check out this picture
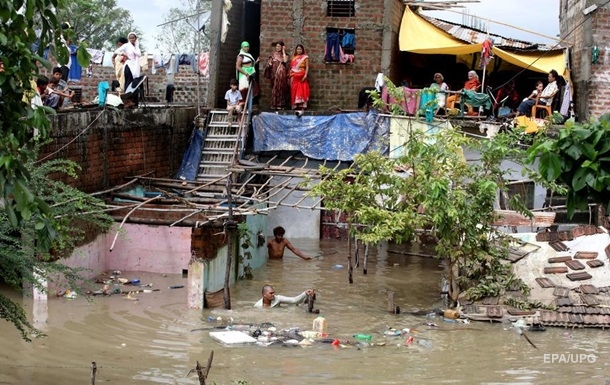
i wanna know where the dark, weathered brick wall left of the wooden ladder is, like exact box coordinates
[40,107,197,192]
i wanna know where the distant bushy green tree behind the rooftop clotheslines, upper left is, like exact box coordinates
[57,0,140,50]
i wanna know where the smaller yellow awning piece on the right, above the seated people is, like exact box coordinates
[492,47,566,75]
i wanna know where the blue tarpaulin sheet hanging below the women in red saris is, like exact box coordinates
[252,112,389,161]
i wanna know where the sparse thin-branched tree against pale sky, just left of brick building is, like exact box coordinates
[155,0,212,52]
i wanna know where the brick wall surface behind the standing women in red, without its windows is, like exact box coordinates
[246,0,402,110]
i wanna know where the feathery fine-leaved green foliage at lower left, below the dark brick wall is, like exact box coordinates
[0,146,113,341]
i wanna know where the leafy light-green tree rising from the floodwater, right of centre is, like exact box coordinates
[310,83,550,301]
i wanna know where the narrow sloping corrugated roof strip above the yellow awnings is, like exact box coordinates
[419,13,558,51]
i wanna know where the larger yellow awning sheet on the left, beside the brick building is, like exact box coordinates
[398,7,482,55]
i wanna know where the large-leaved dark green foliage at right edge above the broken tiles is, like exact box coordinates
[527,115,610,218]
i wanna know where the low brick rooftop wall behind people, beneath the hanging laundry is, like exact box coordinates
[41,59,207,105]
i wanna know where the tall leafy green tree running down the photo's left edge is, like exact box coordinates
[0,0,108,339]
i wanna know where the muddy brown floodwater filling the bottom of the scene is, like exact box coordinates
[0,240,610,385]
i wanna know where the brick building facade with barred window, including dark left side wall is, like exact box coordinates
[208,0,404,111]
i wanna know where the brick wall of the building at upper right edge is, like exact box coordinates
[559,0,610,121]
